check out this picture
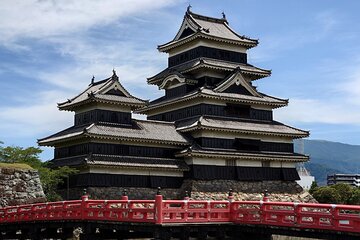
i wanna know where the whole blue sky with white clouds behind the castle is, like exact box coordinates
[0,0,360,160]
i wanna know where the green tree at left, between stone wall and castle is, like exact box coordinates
[0,142,77,201]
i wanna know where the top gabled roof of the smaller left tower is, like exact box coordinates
[58,71,146,111]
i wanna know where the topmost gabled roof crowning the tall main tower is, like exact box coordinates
[158,8,258,52]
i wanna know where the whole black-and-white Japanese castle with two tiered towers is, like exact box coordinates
[38,8,309,198]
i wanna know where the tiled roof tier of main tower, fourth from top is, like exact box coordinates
[177,116,309,138]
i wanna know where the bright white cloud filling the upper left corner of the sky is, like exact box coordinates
[0,0,179,46]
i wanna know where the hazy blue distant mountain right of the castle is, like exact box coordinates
[295,140,360,185]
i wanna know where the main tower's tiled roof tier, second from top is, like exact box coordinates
[148,57,271,85]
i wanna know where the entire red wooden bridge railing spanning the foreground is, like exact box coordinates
[0,194,360,233]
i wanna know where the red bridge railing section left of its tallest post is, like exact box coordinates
[0,196,155,224]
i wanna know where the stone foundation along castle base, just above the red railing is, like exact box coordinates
[60,180,316,202]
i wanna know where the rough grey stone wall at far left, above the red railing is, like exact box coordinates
[0,167,46,207]
